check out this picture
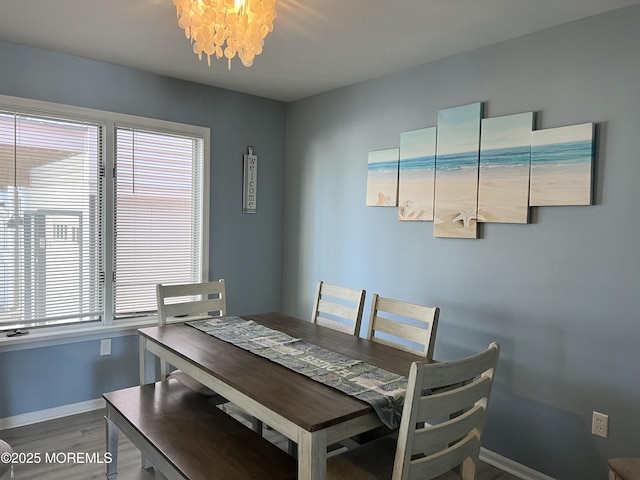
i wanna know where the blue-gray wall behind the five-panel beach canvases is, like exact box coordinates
[283,7,640,480]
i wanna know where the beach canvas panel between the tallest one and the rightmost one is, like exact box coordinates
[478,112,534,223]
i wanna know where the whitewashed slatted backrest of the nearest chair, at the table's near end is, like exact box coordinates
[393,342,500,480]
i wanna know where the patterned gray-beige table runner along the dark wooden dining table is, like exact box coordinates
[186,316,407,428]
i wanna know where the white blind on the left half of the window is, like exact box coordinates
[0,111,103,328]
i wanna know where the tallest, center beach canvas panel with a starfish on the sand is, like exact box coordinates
[433,103,482,238]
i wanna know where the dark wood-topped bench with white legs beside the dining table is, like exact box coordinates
[103,379,297,480]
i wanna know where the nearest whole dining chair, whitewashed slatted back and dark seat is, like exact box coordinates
[327,342,500,480]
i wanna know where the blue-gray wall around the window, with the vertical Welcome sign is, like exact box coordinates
[0,42,286,418]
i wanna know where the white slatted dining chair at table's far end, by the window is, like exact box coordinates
[156,279,227,405]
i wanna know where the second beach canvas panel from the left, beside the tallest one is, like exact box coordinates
[398,127,436,221]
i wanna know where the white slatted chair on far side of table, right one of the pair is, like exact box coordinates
[367,294,440,360]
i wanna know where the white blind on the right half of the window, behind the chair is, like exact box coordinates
[113,128,203,318]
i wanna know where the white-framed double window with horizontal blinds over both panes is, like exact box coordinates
[0,97,208,330]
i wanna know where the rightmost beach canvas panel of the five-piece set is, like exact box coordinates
[529,123,594,206]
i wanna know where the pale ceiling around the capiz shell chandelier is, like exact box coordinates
[0,0,640,101]
